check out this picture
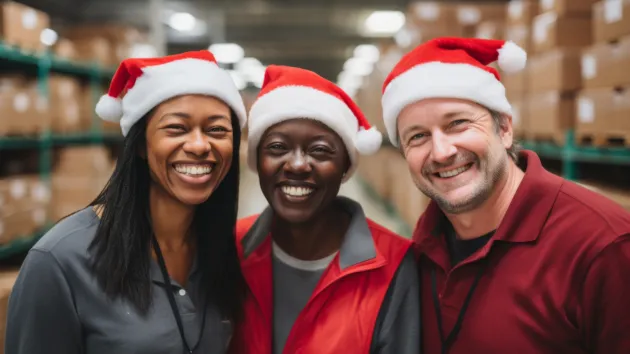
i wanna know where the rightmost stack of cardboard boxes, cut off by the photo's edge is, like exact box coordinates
[575,0,630,146]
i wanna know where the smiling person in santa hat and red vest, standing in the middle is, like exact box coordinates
[231,66,420,354]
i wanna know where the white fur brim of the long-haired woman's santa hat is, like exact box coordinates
[120,58,247,135]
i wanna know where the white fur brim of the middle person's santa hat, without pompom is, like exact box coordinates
[247,86,359,181]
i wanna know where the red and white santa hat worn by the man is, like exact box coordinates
[382,38,527,145]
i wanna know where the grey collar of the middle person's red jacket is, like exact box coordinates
[241,197,376,270]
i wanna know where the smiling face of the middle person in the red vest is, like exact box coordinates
[258,119,349,223]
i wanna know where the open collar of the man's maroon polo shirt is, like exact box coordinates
[413,150,564,252]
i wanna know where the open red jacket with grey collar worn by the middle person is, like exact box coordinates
[230,198,420,354]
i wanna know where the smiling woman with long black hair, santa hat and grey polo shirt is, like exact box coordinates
[5,51,251,354]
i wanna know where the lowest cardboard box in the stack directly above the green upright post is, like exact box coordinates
[526,91,575,139]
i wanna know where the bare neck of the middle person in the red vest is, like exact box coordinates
[271,204,350,261]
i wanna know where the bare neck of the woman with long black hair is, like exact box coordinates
[149,185,195,252]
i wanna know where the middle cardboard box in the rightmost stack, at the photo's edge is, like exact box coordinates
[581,36,630,88]
